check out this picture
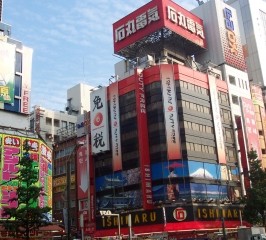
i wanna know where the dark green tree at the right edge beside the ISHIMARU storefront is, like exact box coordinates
[243,149,266,226]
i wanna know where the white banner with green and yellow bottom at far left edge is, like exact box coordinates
[0,41,16,103]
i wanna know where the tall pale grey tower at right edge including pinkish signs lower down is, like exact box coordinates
[226,0,266,169]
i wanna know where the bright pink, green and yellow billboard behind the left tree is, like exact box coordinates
[0,134,52,219]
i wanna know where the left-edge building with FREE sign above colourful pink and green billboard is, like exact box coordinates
[0,0,52,239]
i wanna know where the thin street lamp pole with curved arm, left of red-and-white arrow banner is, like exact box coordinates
[66,142,84,240]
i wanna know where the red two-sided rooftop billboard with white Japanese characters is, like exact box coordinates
[113,0,206,53]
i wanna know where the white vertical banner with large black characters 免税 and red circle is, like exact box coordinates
[90,87,110,154]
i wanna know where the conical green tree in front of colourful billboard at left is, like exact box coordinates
[3,140,51,240]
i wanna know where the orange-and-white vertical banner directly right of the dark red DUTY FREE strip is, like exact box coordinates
[160,64,182,160]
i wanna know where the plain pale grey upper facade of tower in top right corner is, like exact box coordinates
[226,0,266,86]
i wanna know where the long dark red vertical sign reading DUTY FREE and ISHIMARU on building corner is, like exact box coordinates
[135,69,153,209]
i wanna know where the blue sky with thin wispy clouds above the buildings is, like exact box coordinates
[2,0,198,110]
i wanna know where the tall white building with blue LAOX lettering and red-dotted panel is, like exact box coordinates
[192,0,266,172]
